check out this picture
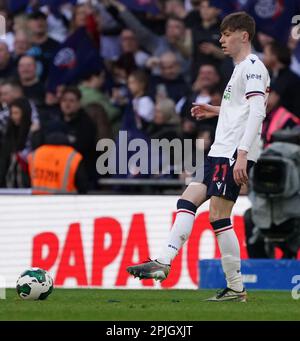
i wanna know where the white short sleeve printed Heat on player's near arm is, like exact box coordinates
[243,59,267,99]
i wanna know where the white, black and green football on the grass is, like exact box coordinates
[16,268,53,300]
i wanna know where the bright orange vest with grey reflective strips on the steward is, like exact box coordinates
[28,144,82,194]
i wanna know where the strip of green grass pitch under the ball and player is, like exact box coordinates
[0,289,300,321]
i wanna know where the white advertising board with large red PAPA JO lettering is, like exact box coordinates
[0,195,250,289]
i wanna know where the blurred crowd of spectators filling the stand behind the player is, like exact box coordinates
[0,0,300,193]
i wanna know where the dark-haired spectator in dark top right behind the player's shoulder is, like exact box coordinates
[263,41,300,117]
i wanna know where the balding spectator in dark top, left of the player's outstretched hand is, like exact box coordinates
[149,51,188,103]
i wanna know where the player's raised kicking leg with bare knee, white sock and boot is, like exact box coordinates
[127,182,207,281]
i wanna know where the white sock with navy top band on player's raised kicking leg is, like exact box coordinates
[157,199,197,264]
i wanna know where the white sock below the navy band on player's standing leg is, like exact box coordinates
[215,222,244,291]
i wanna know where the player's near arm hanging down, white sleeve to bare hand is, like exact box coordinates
[233,61,268,185]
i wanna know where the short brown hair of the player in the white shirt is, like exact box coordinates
[220,12,256,41]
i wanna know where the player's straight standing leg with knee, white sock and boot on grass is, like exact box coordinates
[209,196,246,302]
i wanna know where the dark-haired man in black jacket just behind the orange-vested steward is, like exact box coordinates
[60,87,96,188]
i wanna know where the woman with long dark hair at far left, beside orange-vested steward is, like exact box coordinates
[0,98,38,188]
